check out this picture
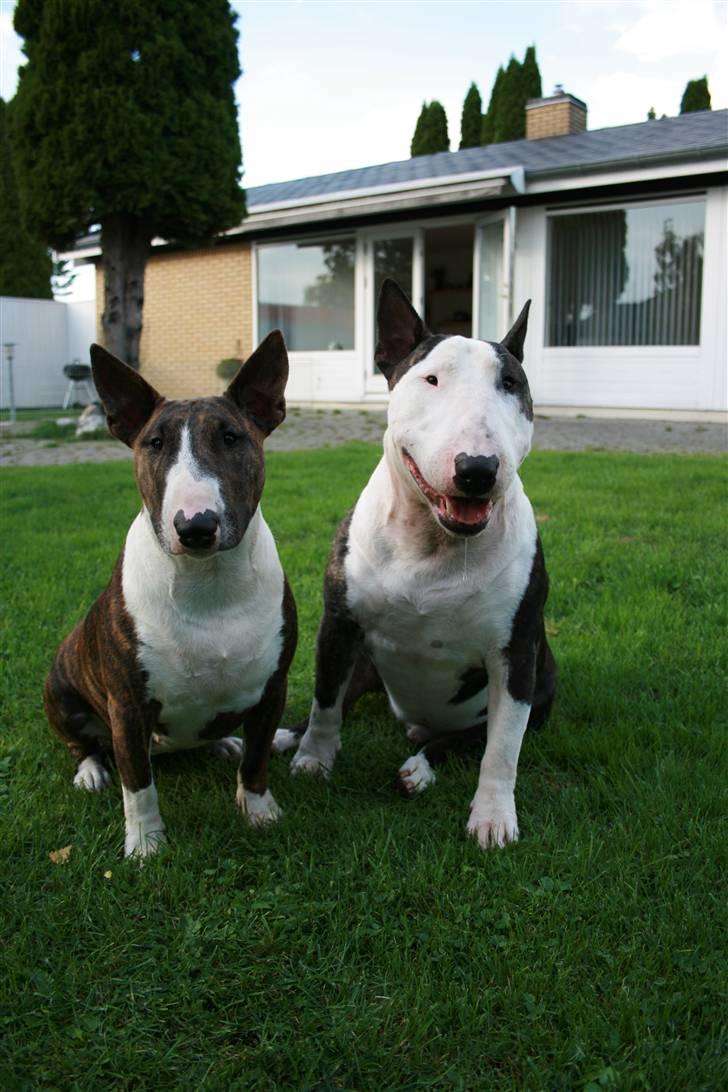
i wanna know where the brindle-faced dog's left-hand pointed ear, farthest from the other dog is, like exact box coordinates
[91,345,164,448]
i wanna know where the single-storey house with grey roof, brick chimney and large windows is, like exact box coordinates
[82,90,728,417]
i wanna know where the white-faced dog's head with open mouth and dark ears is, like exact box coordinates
[377,281,534,535]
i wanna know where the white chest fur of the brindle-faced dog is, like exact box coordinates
[122,509,284,750]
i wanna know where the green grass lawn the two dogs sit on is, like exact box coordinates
[0,444,728,1092]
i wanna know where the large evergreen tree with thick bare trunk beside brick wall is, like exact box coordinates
[13,0,244,366]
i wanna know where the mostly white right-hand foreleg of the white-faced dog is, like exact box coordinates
[467,661,530,850]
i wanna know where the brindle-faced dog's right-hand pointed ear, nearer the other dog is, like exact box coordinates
[225,330,288,436]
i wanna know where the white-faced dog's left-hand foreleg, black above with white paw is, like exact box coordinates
[290,613,363,776]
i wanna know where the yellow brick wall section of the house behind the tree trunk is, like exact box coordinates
[96,242,253,399]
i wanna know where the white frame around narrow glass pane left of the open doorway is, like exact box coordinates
[357,224,425,395]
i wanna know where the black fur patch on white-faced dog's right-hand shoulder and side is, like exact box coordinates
[503,535,557,711]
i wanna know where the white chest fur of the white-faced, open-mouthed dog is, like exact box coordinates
[346,456,536,731]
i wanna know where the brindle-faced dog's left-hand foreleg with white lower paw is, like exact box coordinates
[108,695,166,857]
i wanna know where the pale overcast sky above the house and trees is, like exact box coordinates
[0,0,728,192]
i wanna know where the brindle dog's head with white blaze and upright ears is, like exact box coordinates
[92,331,288,557]
